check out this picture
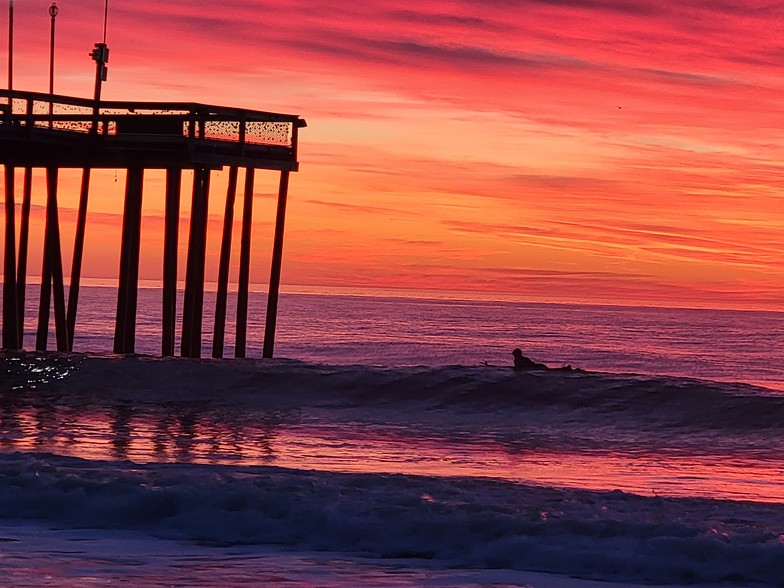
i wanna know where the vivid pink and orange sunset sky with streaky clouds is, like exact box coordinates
[0,0,784,311]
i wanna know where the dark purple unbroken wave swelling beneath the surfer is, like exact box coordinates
[0,353,784,431]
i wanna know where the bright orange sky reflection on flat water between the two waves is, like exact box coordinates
[0,404,784,503]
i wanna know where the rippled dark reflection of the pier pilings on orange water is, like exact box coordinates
[0,385,299,463]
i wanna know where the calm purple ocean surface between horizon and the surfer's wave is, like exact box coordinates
[15,286,784,391]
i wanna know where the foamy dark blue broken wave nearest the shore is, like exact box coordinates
[0,453,784,585]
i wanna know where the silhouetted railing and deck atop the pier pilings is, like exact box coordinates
[0,90,305,171]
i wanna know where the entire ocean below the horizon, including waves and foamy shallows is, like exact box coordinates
[0,286,784,588]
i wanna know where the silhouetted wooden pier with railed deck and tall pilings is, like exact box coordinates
[0,90,305,357]
